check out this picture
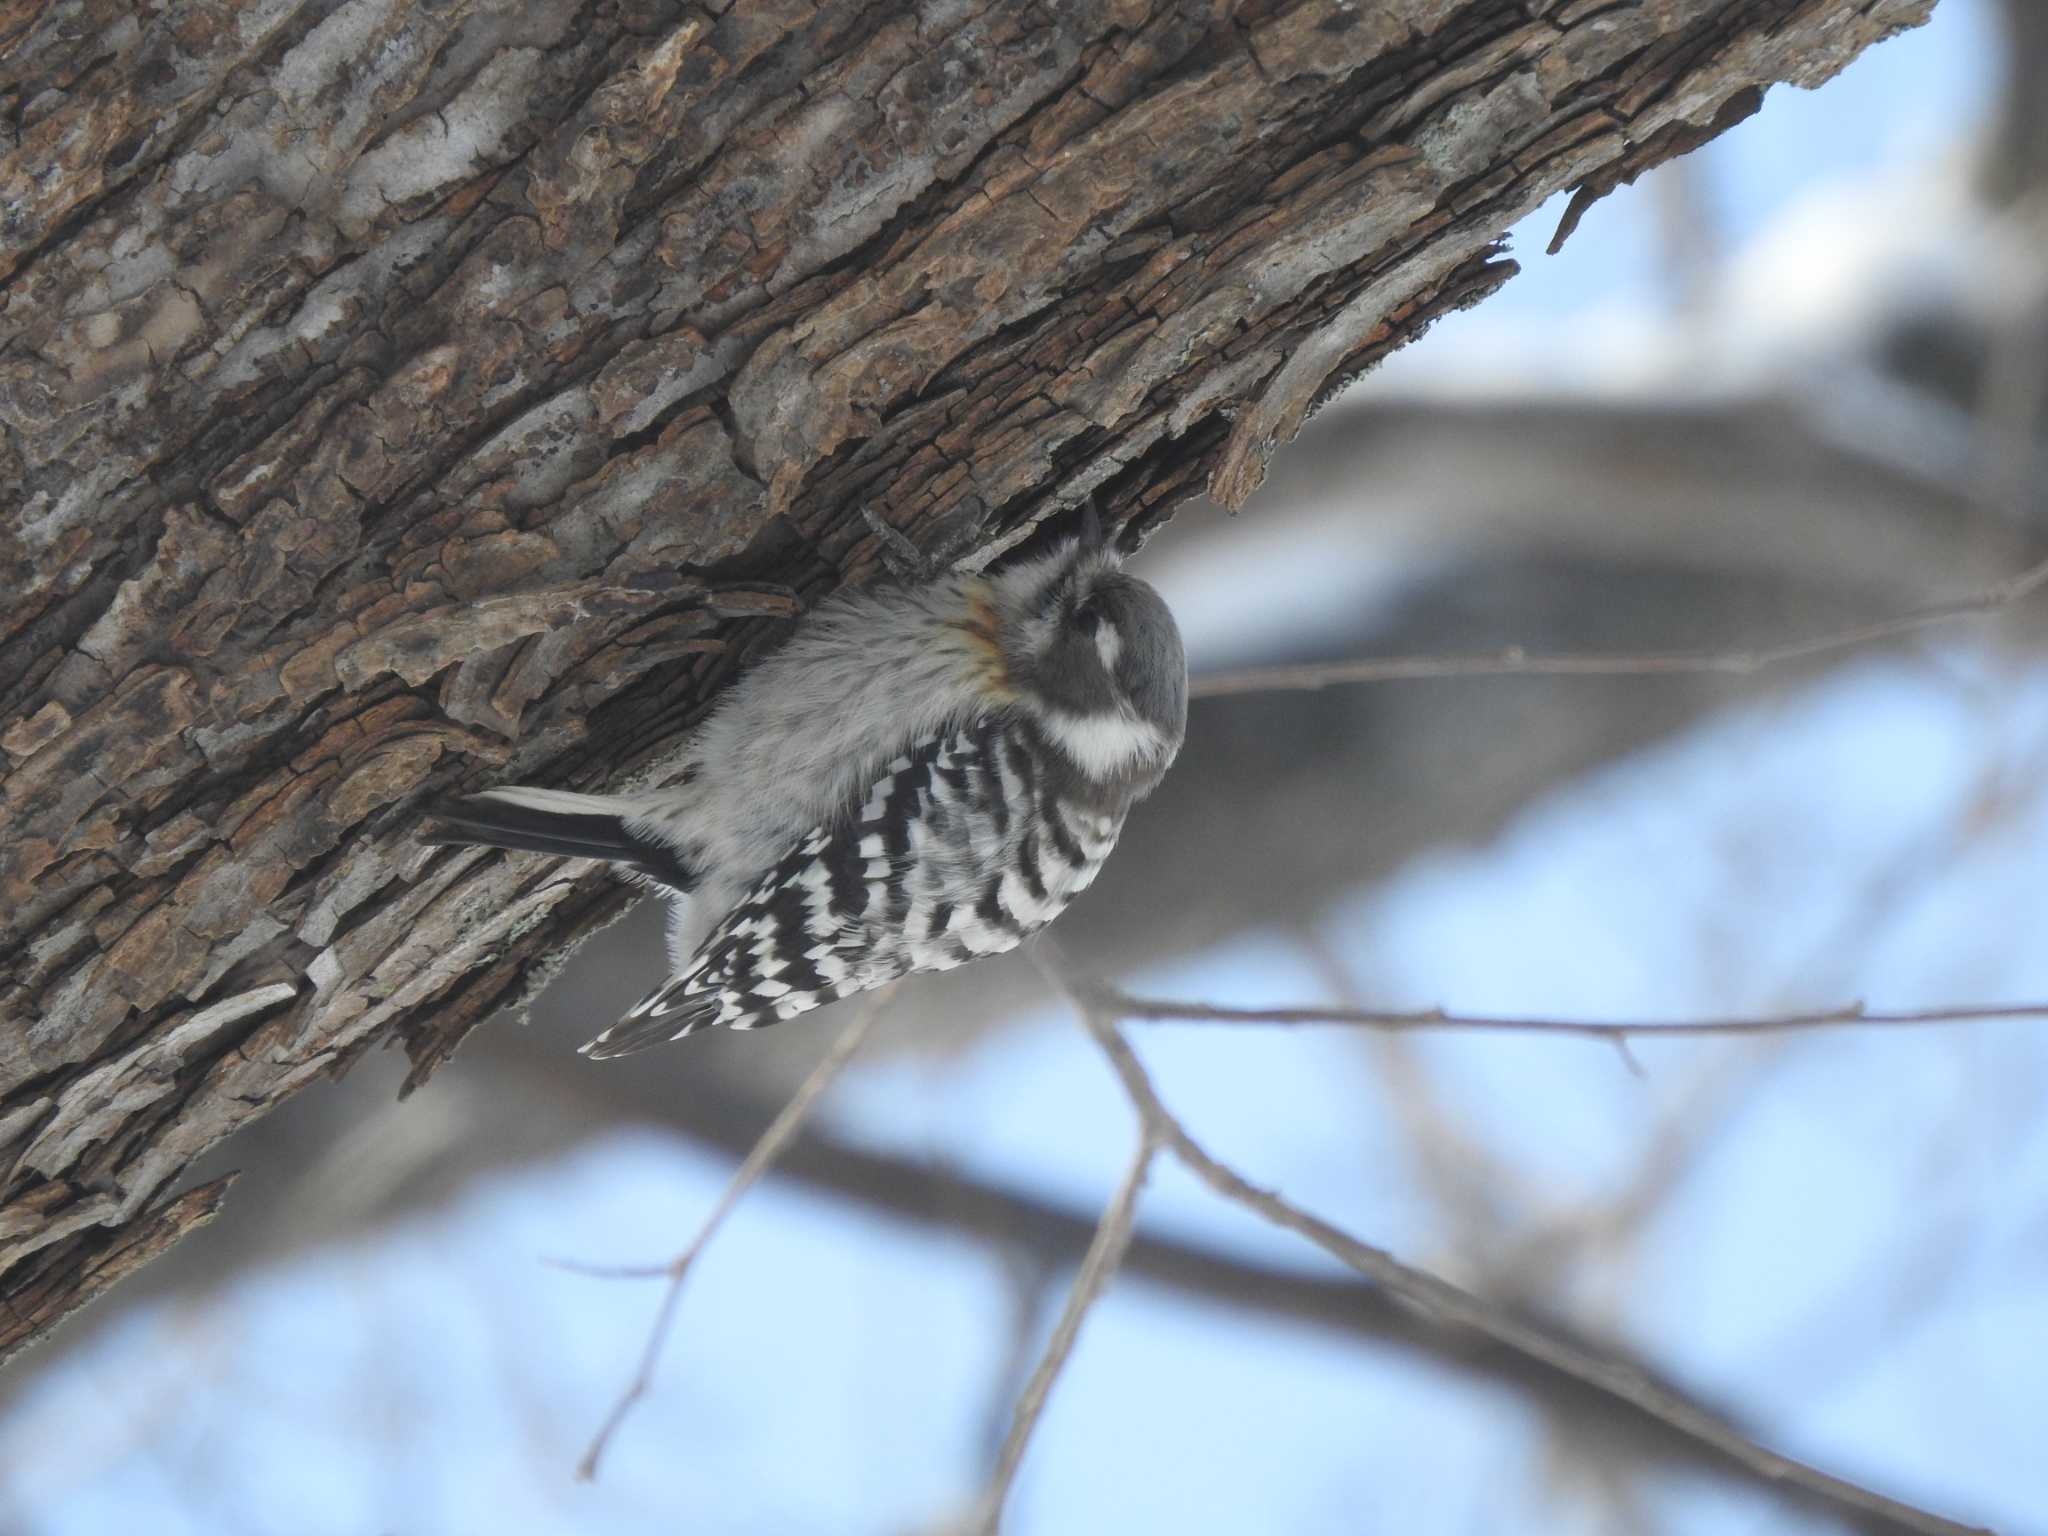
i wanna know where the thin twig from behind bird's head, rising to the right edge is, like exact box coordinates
[1188,561,2048,698]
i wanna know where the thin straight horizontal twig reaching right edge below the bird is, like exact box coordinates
[1097,981,2048,1047]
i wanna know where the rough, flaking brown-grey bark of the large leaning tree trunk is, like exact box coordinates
[0,0,1931,1350]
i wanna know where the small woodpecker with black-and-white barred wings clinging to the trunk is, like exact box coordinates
[422,516,1188,1059]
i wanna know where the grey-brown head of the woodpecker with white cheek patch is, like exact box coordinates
[991,518,1188,791]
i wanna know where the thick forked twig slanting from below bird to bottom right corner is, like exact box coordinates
[1036,954,1985,1536]
